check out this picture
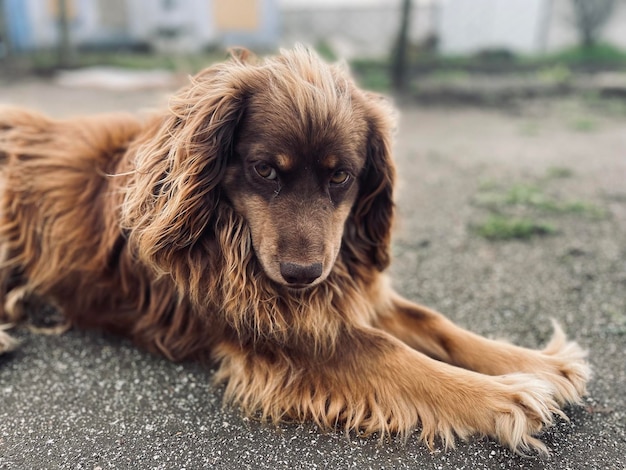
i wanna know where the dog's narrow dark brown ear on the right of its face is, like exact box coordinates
[344,94,395,271]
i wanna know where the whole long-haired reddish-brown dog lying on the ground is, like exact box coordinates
[0,47,589,452]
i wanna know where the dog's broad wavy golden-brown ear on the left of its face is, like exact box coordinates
[122,59,249,274]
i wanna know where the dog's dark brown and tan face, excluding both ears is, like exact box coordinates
[224,86,367,288]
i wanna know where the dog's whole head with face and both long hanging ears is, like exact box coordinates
[124,47,394,294]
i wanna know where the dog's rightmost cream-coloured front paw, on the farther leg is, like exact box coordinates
[535,322,591,405]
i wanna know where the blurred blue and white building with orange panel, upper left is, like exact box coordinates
[2,0,279,53]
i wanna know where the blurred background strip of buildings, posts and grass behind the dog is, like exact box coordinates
[0,0,626,101]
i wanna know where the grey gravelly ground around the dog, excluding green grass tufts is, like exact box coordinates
[0,81,626,469]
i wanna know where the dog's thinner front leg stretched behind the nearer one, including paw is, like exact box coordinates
[376,294,590,404]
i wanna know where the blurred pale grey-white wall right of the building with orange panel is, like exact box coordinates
[280,0,626,57]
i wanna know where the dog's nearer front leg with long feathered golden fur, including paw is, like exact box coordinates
[216,328,560,452]
